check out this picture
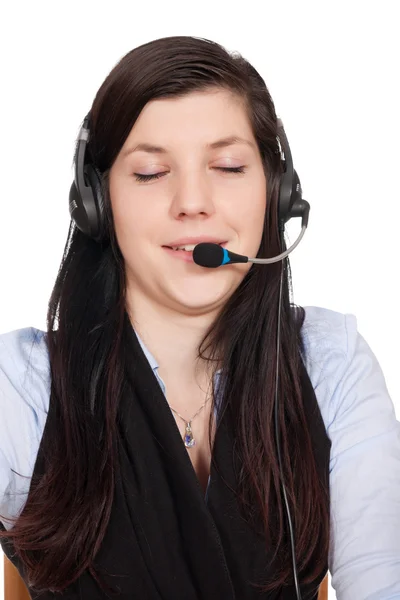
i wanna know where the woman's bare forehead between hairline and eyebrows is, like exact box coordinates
[121,90,255,157]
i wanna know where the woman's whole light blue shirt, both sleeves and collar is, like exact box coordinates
[0,306,400,600]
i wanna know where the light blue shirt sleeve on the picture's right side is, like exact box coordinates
[327,315,400,600]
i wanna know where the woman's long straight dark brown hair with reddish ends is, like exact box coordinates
[1,36,329,591]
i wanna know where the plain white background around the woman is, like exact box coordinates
[0,0,400,599]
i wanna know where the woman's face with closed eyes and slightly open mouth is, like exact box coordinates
[110,90,267,315]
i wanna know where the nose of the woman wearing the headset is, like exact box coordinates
[170,171,215,219]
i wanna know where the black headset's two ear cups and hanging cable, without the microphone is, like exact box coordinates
[69,112,310,600]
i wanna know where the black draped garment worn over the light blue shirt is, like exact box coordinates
[0,313,331,600]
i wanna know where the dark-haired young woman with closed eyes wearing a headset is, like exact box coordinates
[0,36,400,600]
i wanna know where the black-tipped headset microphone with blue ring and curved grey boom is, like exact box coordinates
[193,225,307,269]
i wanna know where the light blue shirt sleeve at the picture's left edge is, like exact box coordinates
[0,327,50,526]
